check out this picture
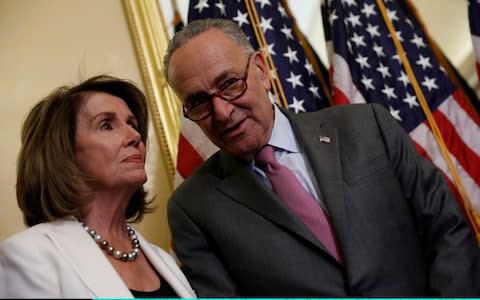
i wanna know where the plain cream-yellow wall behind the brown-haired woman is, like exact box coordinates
[0,0,171,247]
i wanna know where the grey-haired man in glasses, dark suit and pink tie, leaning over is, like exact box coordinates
[164,19,480,297]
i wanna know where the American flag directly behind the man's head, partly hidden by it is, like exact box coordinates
[175,0,331,185]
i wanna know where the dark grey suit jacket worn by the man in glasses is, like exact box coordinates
[168,104,480,297]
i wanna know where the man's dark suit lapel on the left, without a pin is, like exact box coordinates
[218,152,326,251]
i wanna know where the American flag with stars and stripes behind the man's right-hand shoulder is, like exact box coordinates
[322,0,480,238]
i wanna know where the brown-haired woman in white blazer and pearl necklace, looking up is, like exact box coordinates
[0,75,195,298]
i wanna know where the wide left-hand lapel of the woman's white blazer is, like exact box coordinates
[47,217,133,298]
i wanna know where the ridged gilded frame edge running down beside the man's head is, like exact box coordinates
[123,0,181,187]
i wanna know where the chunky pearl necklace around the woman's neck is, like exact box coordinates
[80,222,140,261]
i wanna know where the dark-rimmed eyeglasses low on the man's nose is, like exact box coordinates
[183,53,253,121]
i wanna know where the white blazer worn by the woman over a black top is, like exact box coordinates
[0,217,196,298]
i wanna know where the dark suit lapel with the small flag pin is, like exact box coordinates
[287,113,345,249]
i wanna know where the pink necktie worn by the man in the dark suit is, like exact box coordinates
[255,145,341,262]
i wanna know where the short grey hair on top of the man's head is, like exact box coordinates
[163,19,255,83]
